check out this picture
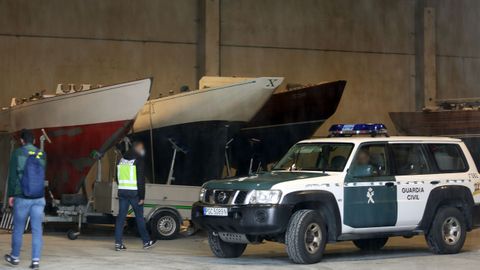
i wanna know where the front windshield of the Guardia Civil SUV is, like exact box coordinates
[273,143,353,172]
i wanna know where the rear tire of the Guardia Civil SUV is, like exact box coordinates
[425,207,467,254]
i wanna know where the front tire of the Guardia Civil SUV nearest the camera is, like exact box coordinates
[285,210,327,264]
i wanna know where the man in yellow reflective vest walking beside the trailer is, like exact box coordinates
[115,142,156,251]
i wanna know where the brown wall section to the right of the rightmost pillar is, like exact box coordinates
[434,0,480,98]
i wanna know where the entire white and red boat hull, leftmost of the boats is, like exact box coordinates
[3,79,152,198]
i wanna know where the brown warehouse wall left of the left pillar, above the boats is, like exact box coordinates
[0,0,197,106]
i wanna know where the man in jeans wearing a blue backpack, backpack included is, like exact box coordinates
[4,130,47,269]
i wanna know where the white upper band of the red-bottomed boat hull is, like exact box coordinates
[8,79,151,132]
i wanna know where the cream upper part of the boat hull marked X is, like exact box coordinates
[133,77,283,132]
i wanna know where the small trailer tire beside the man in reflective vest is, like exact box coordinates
[149,211,181,240]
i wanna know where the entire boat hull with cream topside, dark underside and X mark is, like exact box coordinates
[131,78,283,186]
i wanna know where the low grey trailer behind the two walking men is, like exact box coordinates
[0,148,201,240]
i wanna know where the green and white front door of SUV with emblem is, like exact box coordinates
[343,143,398,229]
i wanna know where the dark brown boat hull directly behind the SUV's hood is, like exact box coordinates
[231,81,346,175]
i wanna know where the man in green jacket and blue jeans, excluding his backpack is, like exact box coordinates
[5,130,47,269]
